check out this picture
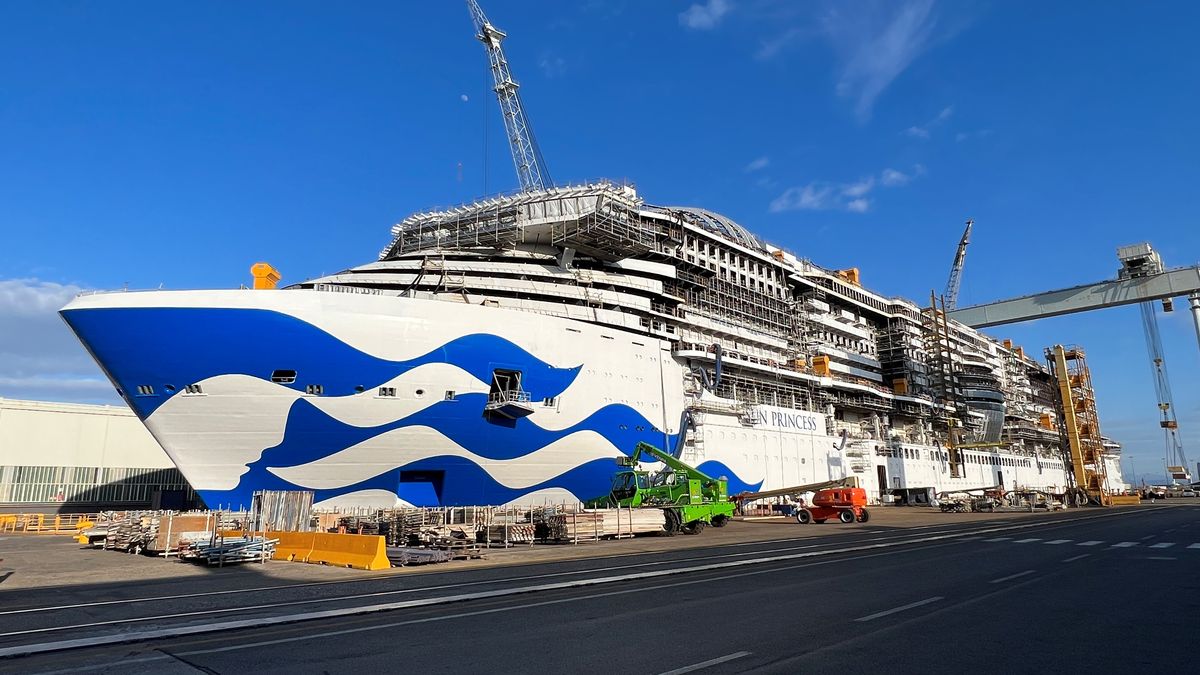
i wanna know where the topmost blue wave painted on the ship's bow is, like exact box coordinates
[61,307,581,419]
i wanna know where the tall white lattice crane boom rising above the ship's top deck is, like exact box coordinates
[467,0,553,192]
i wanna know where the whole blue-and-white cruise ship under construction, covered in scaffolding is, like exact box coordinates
[61,181,1122,508]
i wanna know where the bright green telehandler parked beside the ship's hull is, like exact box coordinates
[588,442,734,536]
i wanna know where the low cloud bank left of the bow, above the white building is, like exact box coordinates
[0,279,120,404]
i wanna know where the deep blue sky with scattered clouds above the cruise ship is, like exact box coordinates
[0,0,1200,474]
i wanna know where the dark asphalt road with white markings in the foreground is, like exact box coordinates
[0,506,1200,674]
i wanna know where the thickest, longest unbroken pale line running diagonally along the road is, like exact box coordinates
[0,507,1165,658]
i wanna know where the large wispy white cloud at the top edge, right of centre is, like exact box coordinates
[822,0,937,120]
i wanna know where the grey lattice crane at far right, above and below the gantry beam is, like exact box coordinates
[1117,243,1192,483]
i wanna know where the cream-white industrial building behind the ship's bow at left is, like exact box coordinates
[0,399,196,512]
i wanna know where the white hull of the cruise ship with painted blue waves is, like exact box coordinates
[61,291,1089,508]
